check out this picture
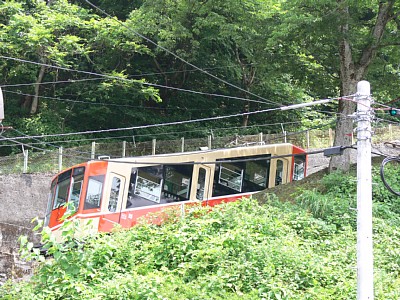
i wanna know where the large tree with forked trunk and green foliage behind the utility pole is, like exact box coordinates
[275,0,400,171]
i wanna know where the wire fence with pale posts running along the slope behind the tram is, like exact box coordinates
[0,125,400,174]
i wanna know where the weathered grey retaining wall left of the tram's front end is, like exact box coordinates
[0,174,53,283]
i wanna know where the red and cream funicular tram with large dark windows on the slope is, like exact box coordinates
[45,143,307,237]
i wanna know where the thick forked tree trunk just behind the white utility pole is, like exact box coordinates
[329,0,395,172]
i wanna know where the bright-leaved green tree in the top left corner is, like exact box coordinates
[0,0,160,133]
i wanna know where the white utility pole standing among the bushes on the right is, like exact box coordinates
[356,81,374,300]
